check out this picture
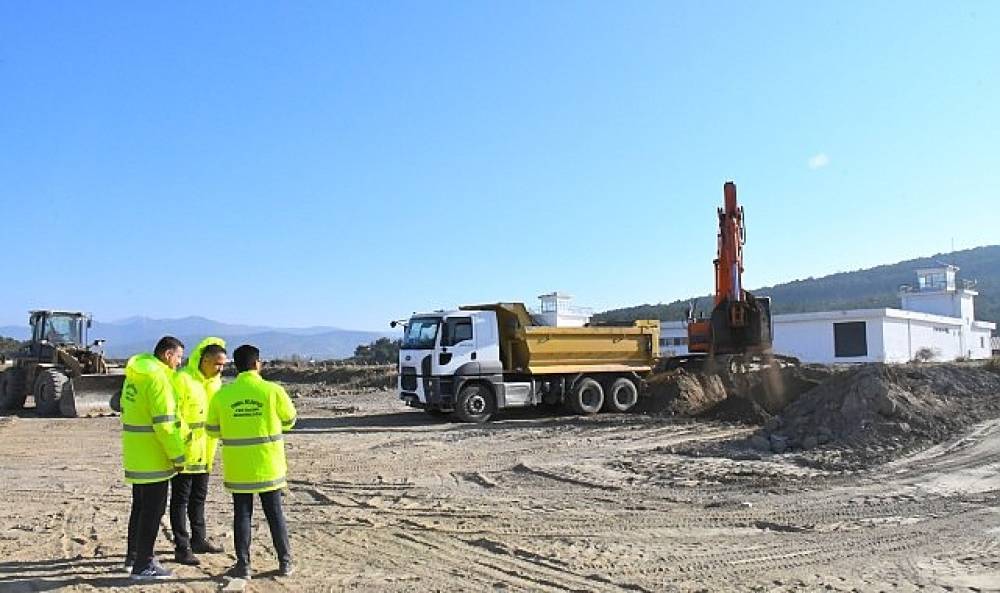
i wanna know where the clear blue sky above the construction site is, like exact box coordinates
[0,2,1000,329]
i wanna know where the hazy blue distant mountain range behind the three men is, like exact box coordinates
[0,317,393,360]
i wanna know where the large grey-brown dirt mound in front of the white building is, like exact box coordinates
[758,364,1000,462]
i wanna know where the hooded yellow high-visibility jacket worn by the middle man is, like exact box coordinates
[174,338,226,474]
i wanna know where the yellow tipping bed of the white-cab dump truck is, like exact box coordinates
[462,303,660,374]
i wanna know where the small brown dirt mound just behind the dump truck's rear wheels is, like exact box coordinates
[638,369,727,416]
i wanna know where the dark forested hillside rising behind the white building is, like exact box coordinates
[594,245,1000,324]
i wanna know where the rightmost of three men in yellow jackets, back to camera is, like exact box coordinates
[206,345,295,579]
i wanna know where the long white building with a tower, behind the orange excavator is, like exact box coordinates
[660,265,996,363]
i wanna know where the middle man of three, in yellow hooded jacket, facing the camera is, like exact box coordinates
[170,338,226,565]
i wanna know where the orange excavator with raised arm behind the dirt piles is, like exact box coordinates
[671,181,772,366]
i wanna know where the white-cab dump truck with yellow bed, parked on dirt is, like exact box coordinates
[393,303,660,423]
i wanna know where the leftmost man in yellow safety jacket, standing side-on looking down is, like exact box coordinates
[121,336,185,580]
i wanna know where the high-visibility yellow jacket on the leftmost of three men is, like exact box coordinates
[121,354,184,484]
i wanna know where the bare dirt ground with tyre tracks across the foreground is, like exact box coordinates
[0,386,1000,592]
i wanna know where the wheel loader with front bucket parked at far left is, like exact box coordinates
[0,310,125,418]
